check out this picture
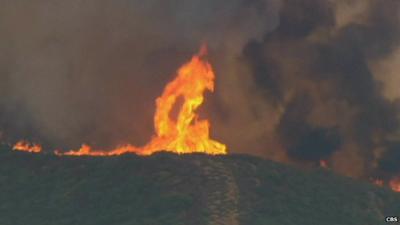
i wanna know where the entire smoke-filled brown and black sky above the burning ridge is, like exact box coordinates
[0,0,400,179]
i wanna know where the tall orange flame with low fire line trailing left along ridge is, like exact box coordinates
[55,46,227,156]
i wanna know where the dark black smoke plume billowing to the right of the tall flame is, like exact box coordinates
[243,0,400,176]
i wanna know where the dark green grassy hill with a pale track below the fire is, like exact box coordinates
[0,144,400,225]
